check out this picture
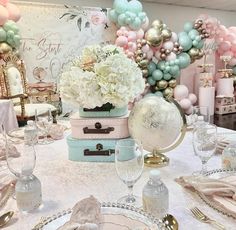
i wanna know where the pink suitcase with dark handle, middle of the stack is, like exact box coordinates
[70,113,129,139]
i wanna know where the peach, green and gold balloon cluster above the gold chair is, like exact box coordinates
[0,0,21,53]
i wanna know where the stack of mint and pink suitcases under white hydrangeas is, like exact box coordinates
[67,107,129,162]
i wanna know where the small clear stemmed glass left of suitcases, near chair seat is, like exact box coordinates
[35,109,53,145]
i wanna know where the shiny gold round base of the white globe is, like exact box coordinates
[144,149,169,167]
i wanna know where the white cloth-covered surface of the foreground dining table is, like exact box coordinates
[0,125,236,230]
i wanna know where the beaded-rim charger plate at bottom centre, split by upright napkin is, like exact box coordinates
[33,203,166,230]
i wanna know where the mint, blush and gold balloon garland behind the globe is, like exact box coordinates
[108,0,209,97]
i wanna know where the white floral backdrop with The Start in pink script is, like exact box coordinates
[16,2,116,87]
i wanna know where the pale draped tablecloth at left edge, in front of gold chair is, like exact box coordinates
[0,100,18,132]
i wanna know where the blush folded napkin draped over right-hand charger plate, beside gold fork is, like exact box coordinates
[175,175,236,217]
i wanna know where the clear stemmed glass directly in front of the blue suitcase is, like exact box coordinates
[115,139,144,206]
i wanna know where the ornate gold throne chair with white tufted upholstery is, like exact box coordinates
[0,53,57,123]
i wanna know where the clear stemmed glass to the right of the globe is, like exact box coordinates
[193,123,217,175]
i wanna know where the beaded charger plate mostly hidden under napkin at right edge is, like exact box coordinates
[198,169,236,219]
